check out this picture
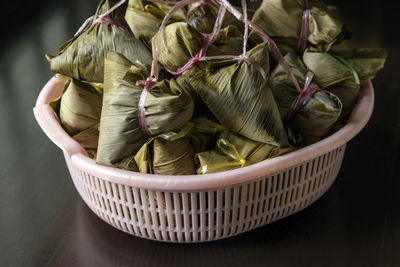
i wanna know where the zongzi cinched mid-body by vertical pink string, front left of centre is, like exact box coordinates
[97,52,193,165]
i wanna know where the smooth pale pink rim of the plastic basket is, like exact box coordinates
[34,77,375,191]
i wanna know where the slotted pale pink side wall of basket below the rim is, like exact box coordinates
[64,145,346,242]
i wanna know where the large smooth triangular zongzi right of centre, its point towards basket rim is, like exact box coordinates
[190,43,288,146]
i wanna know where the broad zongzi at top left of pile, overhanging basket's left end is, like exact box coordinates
[46,0,152,83]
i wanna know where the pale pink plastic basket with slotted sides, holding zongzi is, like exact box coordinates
[34,78,374,242]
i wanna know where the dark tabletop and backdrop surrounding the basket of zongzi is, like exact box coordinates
[0,0,400,267]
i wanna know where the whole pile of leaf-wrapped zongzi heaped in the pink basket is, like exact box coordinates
[47,0,386,177]
